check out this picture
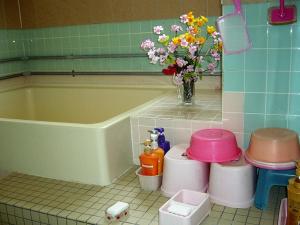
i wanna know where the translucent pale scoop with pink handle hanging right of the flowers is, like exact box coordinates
[217,0,252,54]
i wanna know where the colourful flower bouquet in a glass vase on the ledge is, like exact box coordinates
[141,12,222,104]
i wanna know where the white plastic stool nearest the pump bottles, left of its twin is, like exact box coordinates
[161,144,209,197]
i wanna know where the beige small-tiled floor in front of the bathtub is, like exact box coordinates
[0,168,285,225]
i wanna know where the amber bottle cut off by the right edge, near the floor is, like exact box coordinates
[286,161,300,225]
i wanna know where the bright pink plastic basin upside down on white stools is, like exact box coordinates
[186,129,241,162]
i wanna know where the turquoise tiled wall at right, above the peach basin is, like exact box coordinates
[223,1,300,147]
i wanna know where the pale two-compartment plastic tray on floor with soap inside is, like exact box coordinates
[159,190,211,225]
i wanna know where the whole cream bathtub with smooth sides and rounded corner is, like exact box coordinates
[0,76,166,185]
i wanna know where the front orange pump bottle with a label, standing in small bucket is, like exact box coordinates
[140,139,158,176]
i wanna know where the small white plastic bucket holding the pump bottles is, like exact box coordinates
[135,168,162,191]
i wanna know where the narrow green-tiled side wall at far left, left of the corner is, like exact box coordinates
[0,29,24,77]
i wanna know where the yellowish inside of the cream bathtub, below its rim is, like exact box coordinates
[0,86,163,124]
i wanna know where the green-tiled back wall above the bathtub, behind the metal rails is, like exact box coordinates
[0,17,216,77]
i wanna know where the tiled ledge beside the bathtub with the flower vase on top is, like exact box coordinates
[130,90,223,164]
